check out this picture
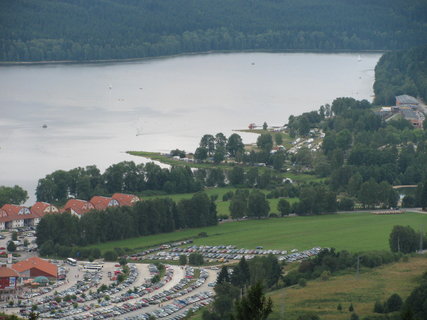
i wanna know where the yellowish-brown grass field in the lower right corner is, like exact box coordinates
[268,255,427,320]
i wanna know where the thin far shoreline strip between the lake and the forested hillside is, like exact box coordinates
[0,49,392,66]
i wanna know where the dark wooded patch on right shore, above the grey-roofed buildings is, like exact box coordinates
[374,44,427,105]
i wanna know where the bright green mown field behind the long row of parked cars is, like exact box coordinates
[90,212,427,252]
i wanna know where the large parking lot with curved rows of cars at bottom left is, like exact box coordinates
[0,261,217,320]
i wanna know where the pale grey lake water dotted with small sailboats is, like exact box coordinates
[0,53,381,204]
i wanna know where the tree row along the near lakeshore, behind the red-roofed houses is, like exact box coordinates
[36,161,206,204]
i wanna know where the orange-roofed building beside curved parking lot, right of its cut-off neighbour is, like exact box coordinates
[12,257,58,279]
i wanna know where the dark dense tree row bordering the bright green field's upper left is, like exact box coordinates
[36,192,217,257]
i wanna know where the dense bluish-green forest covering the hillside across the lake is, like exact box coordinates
[0,0,427,61]
